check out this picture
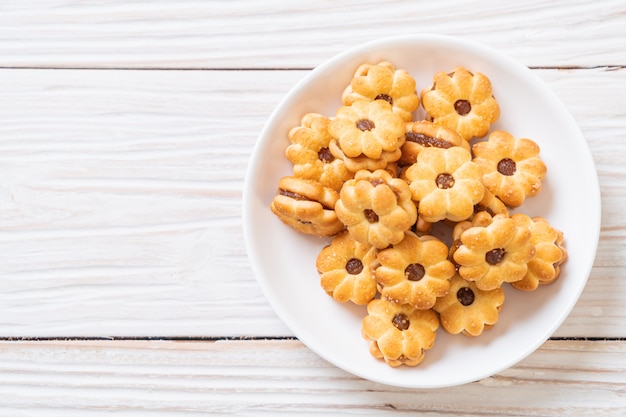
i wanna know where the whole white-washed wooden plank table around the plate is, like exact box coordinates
[0,0,626,416]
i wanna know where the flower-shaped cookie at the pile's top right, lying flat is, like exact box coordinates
[421,67,500,141]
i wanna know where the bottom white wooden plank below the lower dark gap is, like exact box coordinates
[0,341,626,417]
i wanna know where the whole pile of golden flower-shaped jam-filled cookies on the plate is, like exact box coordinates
[271,62,567,367]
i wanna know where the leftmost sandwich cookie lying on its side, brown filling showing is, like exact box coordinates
[270,176,344,237]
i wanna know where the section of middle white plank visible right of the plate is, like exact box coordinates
[537,68,626,337]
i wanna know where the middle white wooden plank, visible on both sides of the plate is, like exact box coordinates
[0,68,626,337]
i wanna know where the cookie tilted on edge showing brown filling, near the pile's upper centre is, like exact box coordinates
[398,120,470,166]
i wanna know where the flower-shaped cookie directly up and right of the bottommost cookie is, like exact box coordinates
[433,274,504,336]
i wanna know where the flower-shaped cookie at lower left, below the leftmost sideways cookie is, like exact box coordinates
[315,231,378,305]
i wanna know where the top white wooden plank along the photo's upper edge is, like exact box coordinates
[0,0,626,68]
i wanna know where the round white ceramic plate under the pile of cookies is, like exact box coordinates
[243,35,600,388]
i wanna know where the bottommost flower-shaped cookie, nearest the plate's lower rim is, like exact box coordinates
[361,298,439,367]
